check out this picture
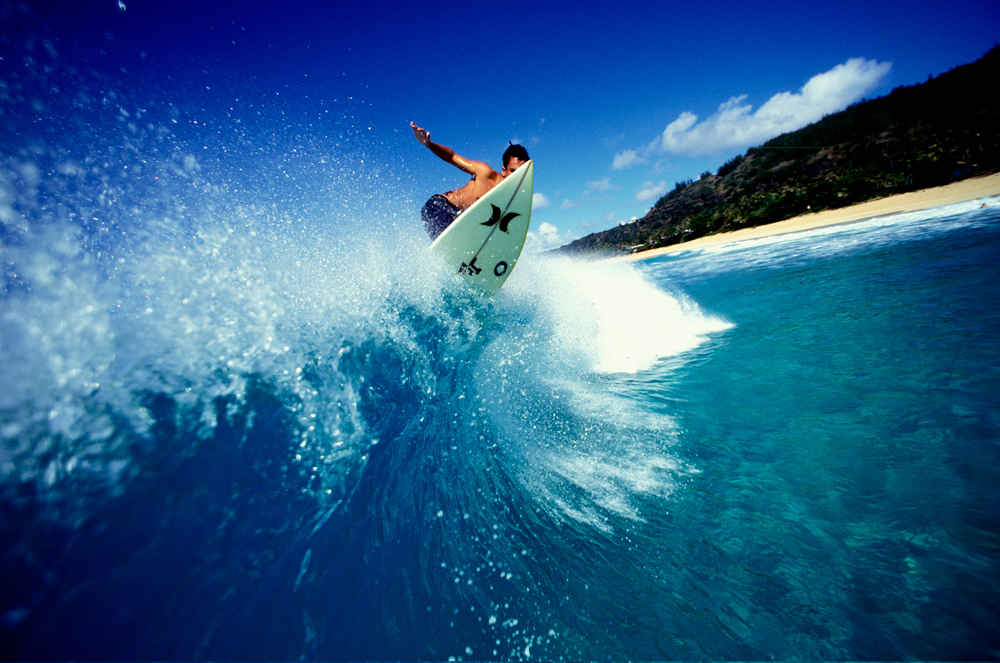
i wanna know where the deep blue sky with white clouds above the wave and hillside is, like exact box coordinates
[15,0,1000,248]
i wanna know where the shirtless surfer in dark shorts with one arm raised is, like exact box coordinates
[410,122,528,240]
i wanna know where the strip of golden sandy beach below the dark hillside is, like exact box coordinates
[610,173,1000,262]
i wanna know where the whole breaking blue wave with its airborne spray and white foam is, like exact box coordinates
[0,28,729,659]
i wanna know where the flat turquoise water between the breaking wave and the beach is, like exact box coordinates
[632,205,1000,659]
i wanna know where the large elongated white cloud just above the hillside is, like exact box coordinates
[652,58,892,156]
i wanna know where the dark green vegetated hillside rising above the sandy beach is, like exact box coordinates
[556,47,1000,254]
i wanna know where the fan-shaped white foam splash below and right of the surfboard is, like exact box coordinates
[478,253,720,531]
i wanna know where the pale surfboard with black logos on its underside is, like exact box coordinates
[431,161,534,293]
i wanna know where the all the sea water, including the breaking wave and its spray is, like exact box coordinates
[0,9,1000,660]
